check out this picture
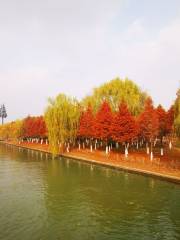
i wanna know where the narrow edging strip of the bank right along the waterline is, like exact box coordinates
[1,141,180,184]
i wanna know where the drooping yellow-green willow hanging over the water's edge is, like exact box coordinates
[45,94,80,155]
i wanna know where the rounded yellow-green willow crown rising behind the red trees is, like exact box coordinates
[82,78,147,115]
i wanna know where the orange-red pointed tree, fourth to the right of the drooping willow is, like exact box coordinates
[139,98,159,146]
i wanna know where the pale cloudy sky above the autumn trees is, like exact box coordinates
[0,0,180,121]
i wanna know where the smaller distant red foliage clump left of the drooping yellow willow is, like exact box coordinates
[23,116,47,138]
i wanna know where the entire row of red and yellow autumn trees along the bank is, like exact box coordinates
[0,79,180,157]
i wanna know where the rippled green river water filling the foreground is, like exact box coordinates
[0,144,180,240]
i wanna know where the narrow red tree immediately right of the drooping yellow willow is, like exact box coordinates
[78,104,94,138]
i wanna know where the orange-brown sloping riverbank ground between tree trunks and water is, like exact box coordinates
[4,141,180,183]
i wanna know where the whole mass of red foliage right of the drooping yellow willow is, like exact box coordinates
[78,98,174,143]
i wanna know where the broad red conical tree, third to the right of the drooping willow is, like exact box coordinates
[111,102,138,143]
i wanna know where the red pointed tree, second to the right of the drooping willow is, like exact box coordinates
[95,101,113,143]
